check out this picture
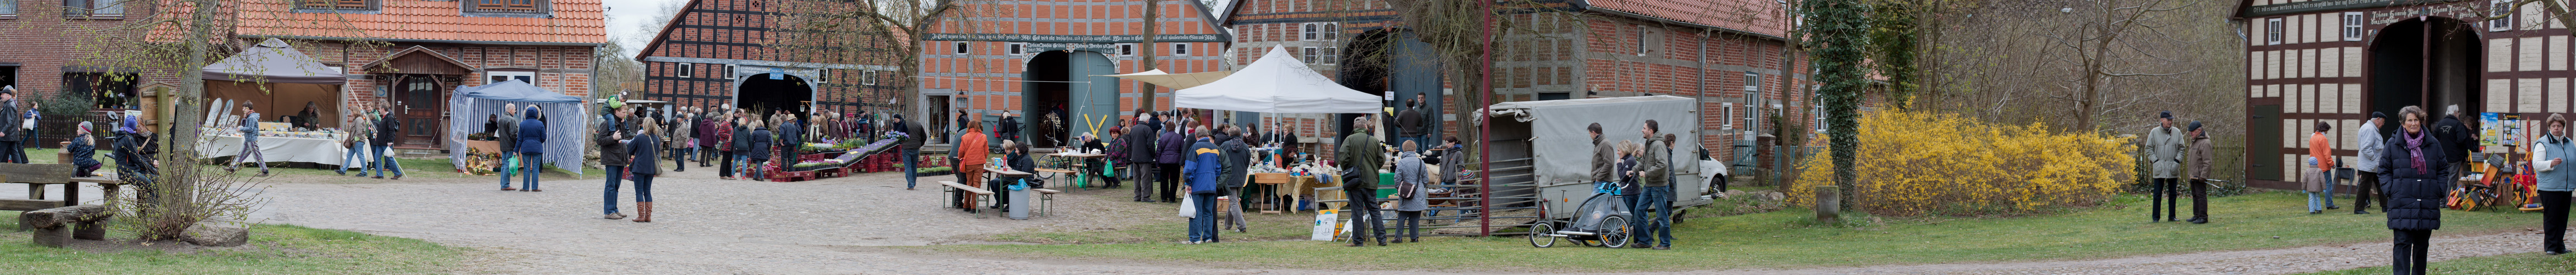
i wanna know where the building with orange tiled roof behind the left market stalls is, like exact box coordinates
[232,0,608,152]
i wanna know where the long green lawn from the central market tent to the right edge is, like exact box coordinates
[925,193,2540,272]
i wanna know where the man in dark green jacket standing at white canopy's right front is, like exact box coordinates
[1332,116,1386,247]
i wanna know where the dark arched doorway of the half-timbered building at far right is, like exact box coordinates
[2365,18,2486,134]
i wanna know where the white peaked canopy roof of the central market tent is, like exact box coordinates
[1175,46,1380,113]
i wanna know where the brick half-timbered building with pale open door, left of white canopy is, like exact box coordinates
[914,0,1231,146]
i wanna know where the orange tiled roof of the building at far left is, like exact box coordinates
[237,0,608,43]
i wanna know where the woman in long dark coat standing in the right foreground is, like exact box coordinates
[2380,106,2452,275]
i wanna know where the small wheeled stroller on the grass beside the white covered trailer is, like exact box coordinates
[1530,183,1636,249]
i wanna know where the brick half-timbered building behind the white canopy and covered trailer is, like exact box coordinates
[1224,0,1808,160]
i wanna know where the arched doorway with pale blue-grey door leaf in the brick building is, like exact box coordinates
[1020,51,1118,146]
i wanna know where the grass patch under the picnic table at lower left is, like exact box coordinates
[0,211,469,275]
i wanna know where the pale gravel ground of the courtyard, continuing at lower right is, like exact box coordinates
[237,167,2540,275]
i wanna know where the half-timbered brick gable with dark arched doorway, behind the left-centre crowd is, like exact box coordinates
[636,0,904,113]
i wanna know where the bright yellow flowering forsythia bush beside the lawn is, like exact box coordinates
[1783,111,2136,216]
